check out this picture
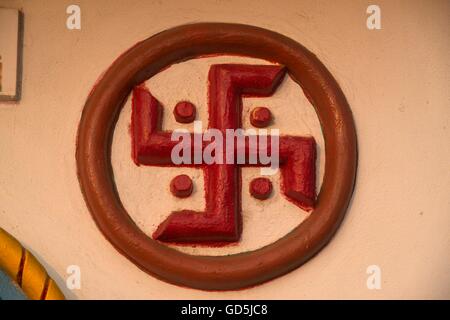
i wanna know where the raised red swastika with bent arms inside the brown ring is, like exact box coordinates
[131,64,316,245]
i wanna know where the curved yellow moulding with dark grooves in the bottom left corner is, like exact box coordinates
[0,228,65,300]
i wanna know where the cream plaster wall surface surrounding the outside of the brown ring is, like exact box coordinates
[0,0,450,299]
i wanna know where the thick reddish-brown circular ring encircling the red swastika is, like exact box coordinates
[76,23,357,290]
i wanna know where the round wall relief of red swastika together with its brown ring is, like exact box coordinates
[76,23,357,290]
